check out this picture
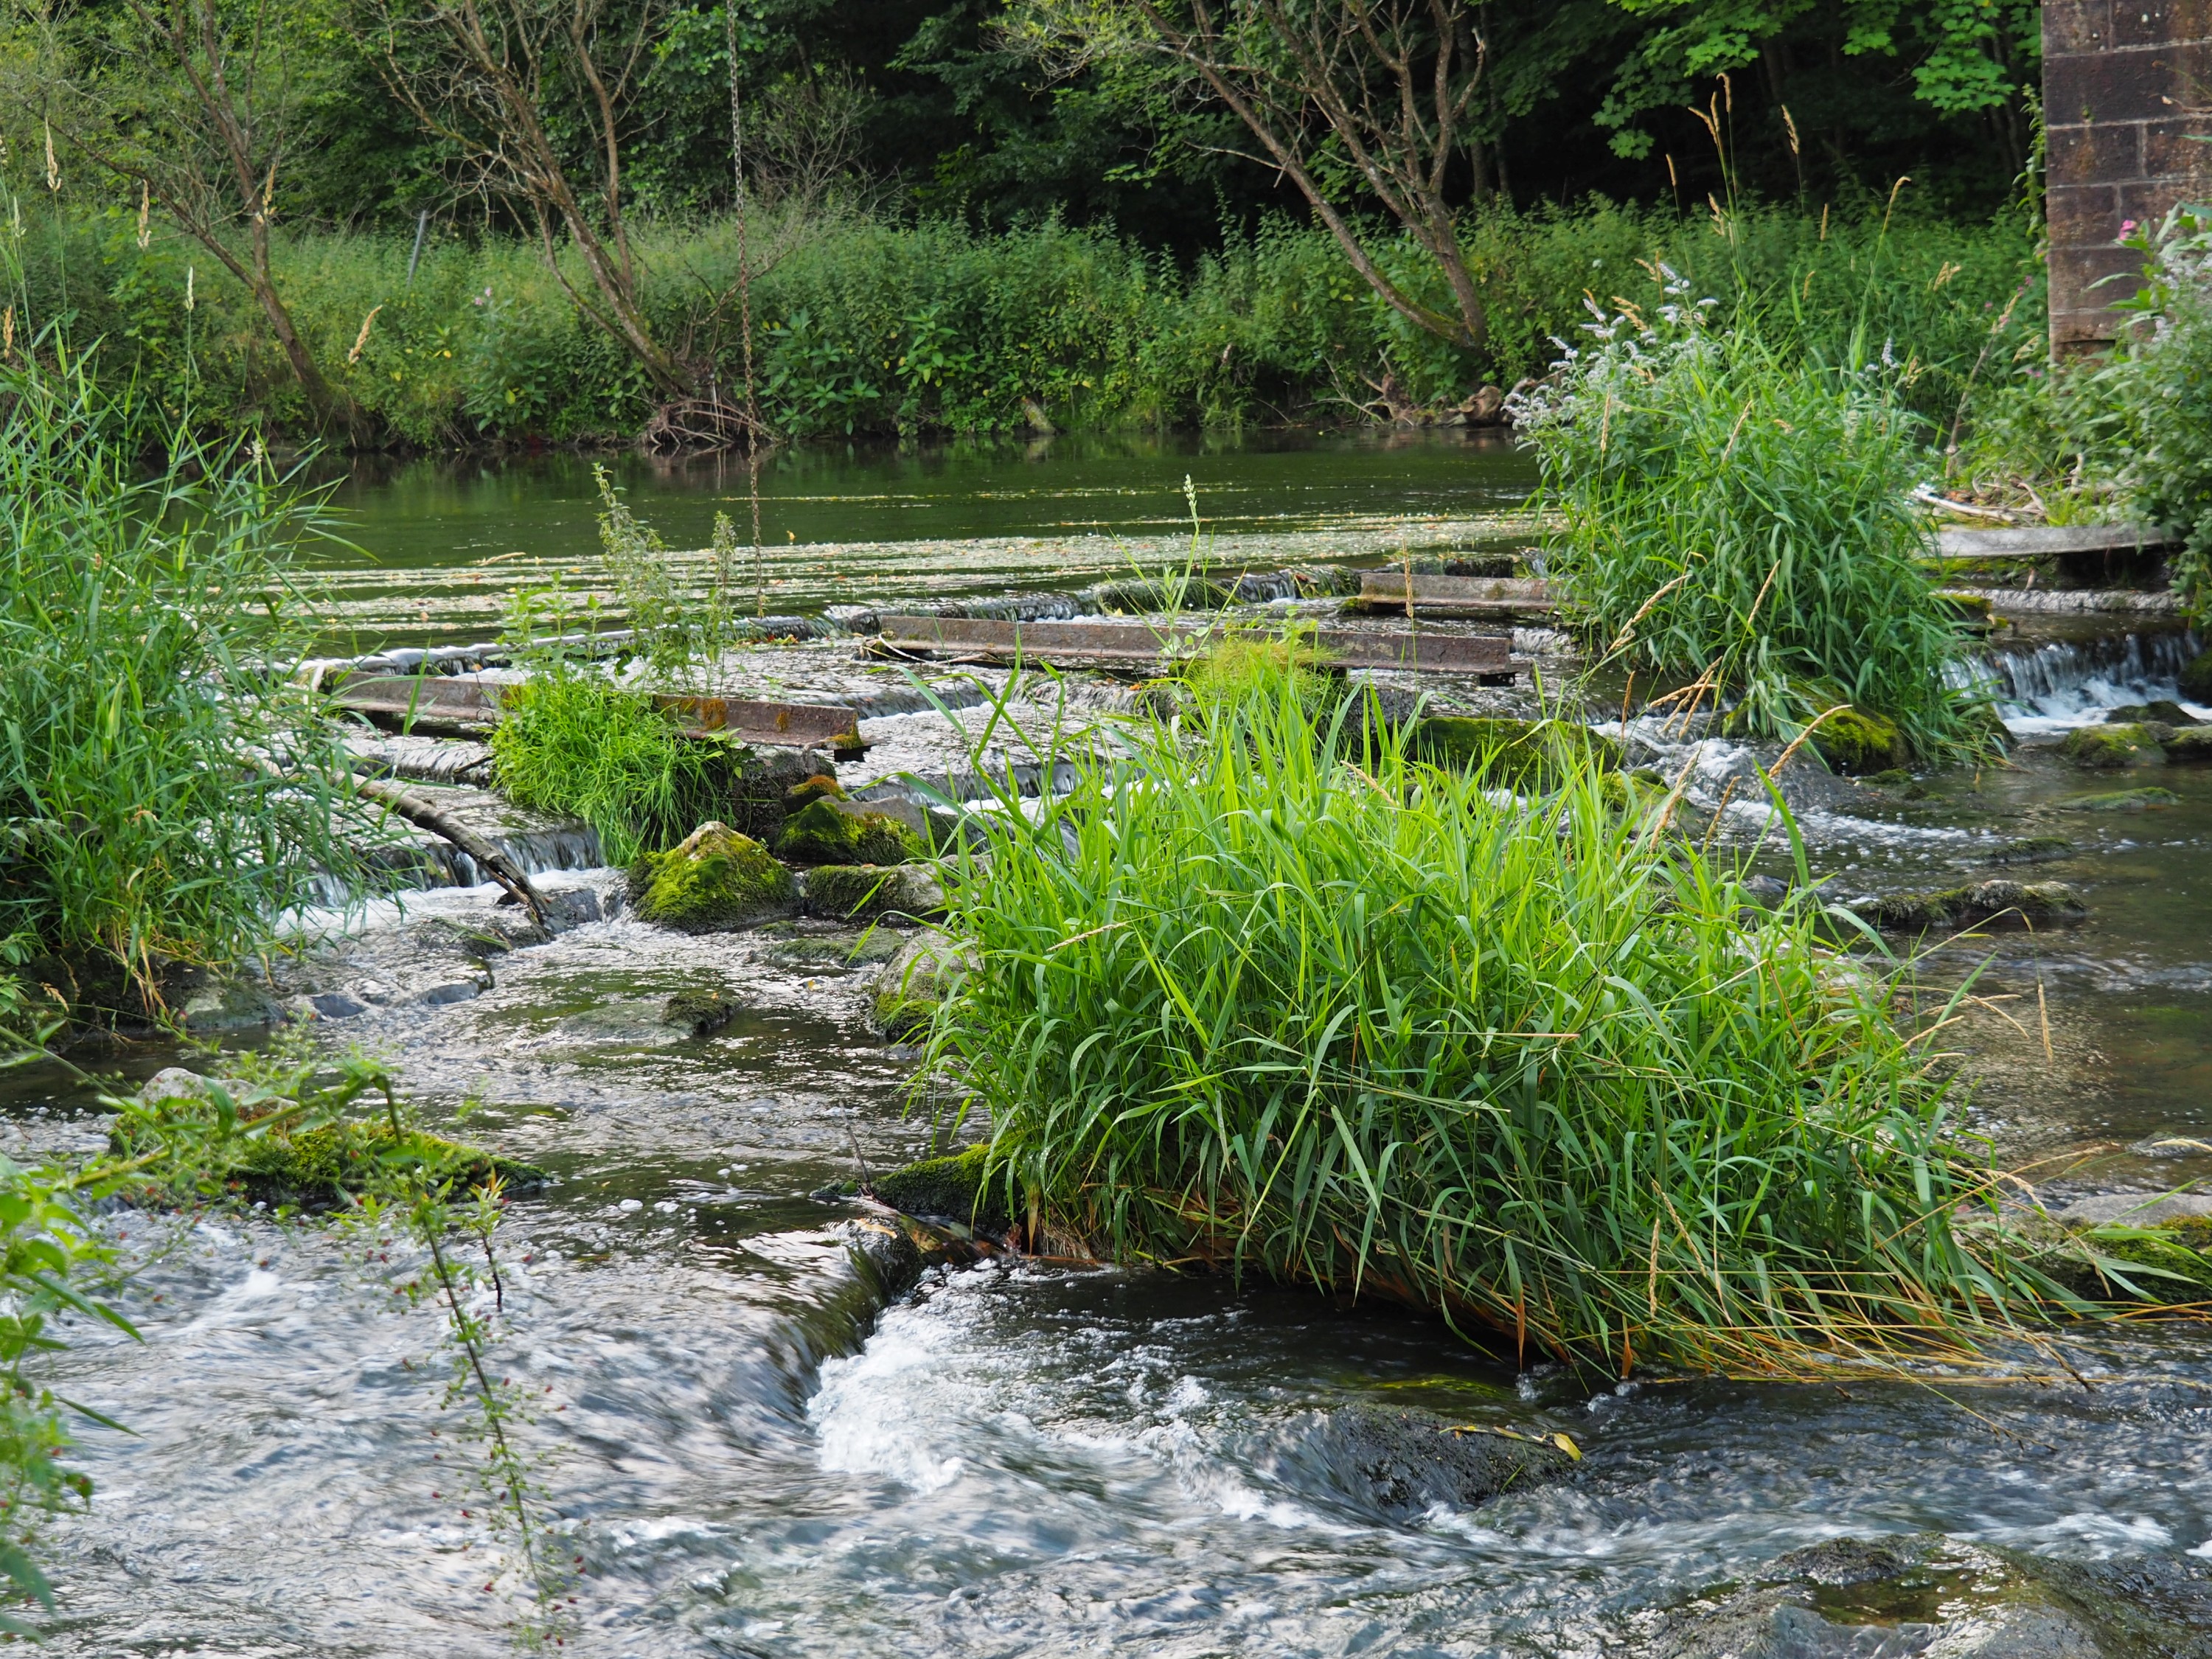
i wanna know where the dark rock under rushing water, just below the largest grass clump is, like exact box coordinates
[1310,1407,1582,1517]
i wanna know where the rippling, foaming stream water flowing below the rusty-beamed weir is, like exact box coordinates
[11,445,2212,1659]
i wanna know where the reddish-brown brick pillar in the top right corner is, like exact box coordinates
[2044,0,2212,356]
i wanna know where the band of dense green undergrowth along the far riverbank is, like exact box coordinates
[4,204,2039,447]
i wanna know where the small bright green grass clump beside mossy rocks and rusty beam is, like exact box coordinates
[491,664,743,865]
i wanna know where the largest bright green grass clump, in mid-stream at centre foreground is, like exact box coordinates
[922,677,2141,1378]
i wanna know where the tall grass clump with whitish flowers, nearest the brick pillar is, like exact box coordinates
[1520,294,1986,759]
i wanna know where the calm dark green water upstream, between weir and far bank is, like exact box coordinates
[321,431,1535,650]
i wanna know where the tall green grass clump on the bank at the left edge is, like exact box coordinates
[0,341,358,1006]
